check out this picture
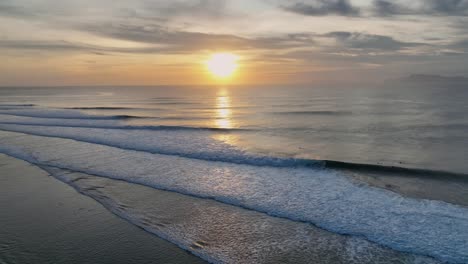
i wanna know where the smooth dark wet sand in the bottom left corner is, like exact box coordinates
[0,154,205,263]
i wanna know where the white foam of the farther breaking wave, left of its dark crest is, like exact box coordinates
[0,120,321,166]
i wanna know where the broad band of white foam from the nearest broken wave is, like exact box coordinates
[0,129,468,263]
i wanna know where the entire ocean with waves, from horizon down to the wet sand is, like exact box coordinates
[0,85,468,263]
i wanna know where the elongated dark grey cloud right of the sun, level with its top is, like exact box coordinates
[322,31,424,51]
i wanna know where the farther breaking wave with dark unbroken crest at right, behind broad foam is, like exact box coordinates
[0,122,468,181]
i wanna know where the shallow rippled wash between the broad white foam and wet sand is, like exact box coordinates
[42,167,439,264]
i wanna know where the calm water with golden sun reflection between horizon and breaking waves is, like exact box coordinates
[0,86,468,173]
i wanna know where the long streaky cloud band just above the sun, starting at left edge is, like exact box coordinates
[0,24,426,55]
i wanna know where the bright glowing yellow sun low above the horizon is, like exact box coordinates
[205,53,239,79]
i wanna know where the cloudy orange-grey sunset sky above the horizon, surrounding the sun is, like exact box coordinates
[0,0,468,86]
